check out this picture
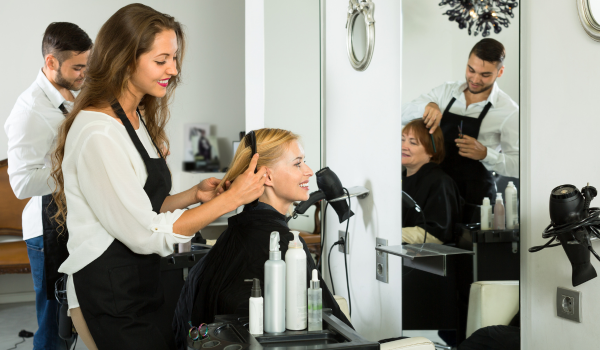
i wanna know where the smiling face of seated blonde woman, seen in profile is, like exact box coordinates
[265,140,313,205]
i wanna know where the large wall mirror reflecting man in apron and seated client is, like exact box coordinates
[401,0,522,346]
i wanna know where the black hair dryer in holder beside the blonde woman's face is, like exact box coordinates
[291,167,354,224]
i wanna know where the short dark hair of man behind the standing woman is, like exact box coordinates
[42,22,93,63]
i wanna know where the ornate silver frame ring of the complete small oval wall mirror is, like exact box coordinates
[346,0,375,71]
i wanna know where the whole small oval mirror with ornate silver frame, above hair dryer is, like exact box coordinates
[346,0,376,71]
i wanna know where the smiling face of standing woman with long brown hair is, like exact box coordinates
[129,30,178,98]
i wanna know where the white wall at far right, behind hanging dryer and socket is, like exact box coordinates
[521,0,600,350]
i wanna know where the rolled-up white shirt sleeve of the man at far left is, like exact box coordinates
[4,108,55,199]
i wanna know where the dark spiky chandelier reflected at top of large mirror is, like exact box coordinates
[440,0,519,37]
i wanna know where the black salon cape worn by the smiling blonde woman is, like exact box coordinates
[173,203,352,350]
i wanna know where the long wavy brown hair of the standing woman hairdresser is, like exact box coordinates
[51,4,185,231]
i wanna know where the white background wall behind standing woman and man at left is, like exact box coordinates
[0,0,245,194]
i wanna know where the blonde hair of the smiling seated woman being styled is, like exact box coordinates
[218,128,300,188]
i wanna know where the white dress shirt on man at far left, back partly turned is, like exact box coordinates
[4,70,78,240]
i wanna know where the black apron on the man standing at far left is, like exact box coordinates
[41,104,69,300]
